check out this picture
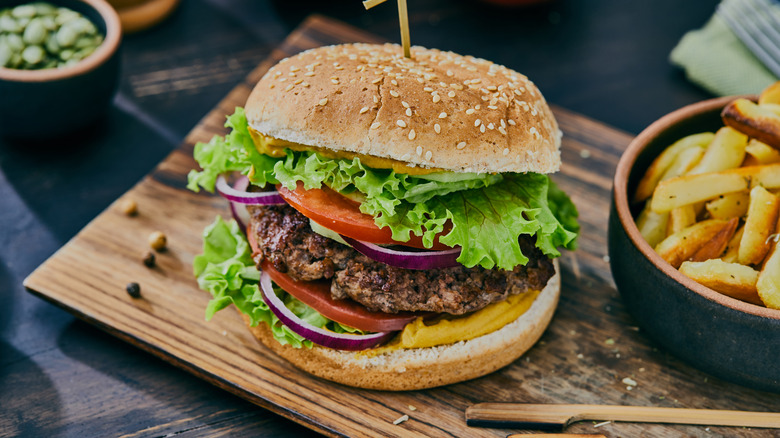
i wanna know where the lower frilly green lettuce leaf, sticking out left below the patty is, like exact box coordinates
[193,216,363,348]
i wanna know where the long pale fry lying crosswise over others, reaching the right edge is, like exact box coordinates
[651,164,780,213]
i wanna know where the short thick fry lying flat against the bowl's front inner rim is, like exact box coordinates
[680,259,762,305]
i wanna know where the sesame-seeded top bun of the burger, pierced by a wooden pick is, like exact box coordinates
[246,44,561,173]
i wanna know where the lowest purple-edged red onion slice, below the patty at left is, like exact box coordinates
[260,271,394,351]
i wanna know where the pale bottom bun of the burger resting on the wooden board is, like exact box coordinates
[241,260,561,391]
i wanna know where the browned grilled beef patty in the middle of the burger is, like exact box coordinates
[249,205,555,315]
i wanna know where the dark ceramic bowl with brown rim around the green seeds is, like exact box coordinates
[0,0,122,140]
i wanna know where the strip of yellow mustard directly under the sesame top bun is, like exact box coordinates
[249,126,444,175]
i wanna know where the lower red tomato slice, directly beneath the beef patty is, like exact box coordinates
[261,260,418,332]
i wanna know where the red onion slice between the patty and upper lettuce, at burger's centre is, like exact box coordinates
[340,235,460,270]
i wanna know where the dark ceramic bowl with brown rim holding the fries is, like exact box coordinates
[609,97,780,392]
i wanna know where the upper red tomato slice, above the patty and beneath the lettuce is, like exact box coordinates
[276,182,451,250]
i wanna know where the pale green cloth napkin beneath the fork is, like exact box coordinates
[669,9,780,96]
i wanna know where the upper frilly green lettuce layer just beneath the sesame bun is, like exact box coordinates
[189,108,579,269]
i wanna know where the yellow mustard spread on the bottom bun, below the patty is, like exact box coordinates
[365,291,539,356]
